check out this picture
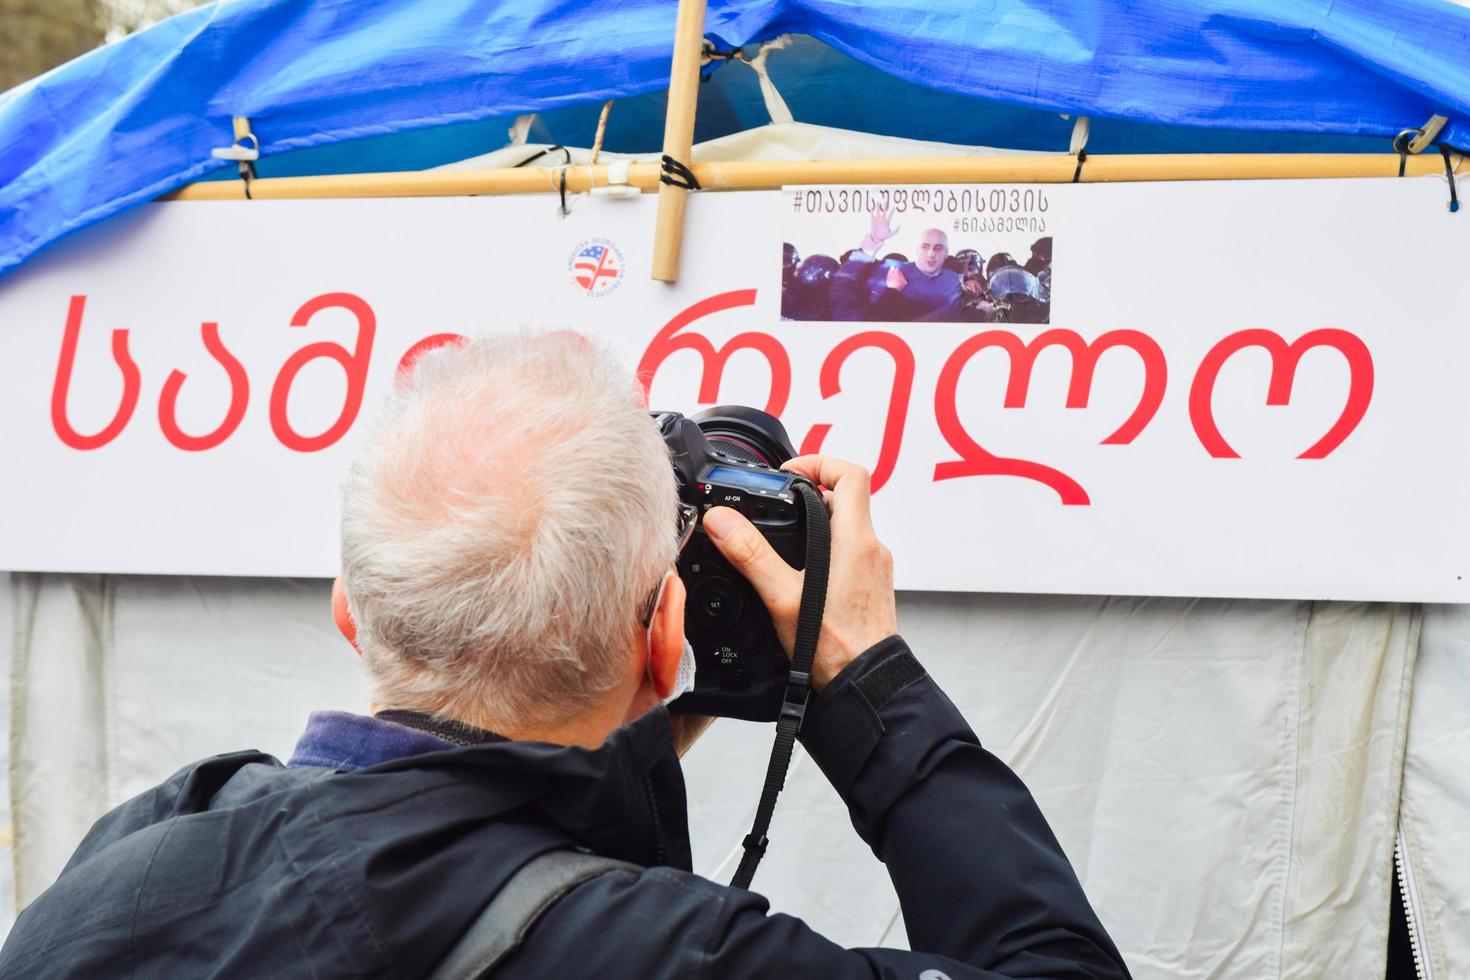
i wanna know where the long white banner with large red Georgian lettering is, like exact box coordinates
[0,178,1470,601]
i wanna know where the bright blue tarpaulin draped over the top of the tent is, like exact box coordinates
[0,0,1470,282]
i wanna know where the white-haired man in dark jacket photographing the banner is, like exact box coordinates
[0,335,1125,980]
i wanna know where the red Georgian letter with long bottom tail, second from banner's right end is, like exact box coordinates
[933,329,1169,507]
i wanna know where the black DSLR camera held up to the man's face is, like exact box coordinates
[650,406,807,721]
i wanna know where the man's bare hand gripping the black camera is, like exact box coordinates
[704,455,898,692]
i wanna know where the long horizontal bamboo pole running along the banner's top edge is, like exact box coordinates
[163,153,1467,201]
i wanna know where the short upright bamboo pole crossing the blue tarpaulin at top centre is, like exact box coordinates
[651,0,704,282]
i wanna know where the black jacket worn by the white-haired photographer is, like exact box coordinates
[0,638,1126,980]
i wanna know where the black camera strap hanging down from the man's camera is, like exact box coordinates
[731,482,832,887]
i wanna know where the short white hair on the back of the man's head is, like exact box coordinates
[343,332,676,730]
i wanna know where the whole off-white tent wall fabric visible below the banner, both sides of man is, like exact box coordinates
[0,574,1446,977]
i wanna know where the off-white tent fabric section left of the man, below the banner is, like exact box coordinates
[10,573,368,907]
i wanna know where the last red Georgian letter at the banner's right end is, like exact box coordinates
[1189,328,1373,460]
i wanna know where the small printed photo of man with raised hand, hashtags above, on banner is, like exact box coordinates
[781,187,1053,323]
